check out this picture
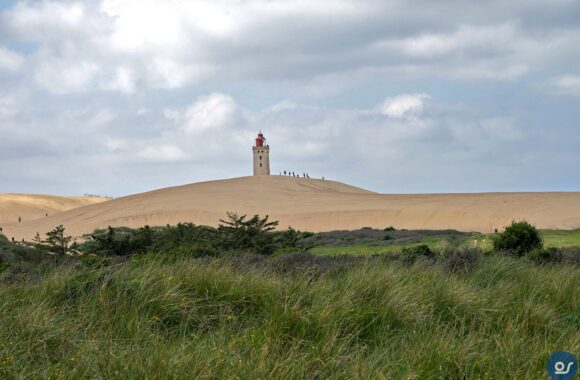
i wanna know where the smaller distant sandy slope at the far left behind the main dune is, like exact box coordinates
[0,194,108,226]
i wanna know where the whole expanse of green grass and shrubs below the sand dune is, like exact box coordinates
[0,214,580,379]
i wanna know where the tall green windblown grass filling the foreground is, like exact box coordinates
[0,256,580,379]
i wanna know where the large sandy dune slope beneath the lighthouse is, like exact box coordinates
[5,176,580,239]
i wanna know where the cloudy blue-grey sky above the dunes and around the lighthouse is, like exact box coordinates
[0,0,580,196]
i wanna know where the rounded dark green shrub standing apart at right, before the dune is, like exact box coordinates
[493,221,544,256]
